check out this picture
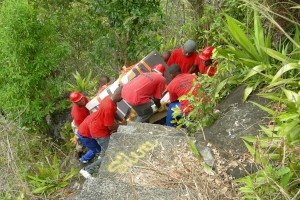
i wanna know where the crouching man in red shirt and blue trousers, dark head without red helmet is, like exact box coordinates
[166,64,202,126]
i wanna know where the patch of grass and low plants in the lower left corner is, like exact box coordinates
[0,116,77,200]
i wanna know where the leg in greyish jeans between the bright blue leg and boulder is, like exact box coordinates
[84,138,109,174]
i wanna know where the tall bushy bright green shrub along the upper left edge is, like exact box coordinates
[0,0,66,128]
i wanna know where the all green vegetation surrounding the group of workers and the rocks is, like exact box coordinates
[0,0,300,199]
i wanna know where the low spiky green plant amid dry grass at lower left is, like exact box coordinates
[26,154,78,196]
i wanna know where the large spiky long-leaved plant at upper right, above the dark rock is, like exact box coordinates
[217,8,300,101]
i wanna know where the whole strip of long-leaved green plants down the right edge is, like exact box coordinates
[218,7,300,199]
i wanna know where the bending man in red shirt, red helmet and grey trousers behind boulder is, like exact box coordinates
[122,64,166,122]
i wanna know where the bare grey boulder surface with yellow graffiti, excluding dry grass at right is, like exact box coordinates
[71,123,201,200]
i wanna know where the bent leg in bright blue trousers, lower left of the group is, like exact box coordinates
[76,133,101,163]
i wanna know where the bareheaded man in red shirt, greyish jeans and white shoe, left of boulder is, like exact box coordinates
[80,87,123,178]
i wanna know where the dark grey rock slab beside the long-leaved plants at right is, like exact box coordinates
[196,86,269,157]
